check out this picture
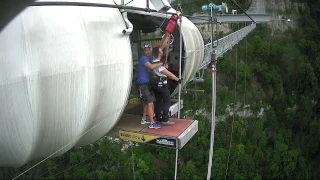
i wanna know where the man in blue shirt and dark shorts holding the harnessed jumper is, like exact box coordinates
[137,33,170,129]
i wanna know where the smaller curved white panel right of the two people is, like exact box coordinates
[172,17,204,96]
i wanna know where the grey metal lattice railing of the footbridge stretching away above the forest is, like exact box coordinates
[200,23,256,69]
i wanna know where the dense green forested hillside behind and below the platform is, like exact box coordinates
[0,0,320,179]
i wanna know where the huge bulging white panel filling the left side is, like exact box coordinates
[0,0,132,167]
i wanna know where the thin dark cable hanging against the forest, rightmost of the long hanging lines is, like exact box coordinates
[224,24,239,180]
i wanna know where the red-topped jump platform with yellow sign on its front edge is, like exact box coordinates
[109,106,198,149]
